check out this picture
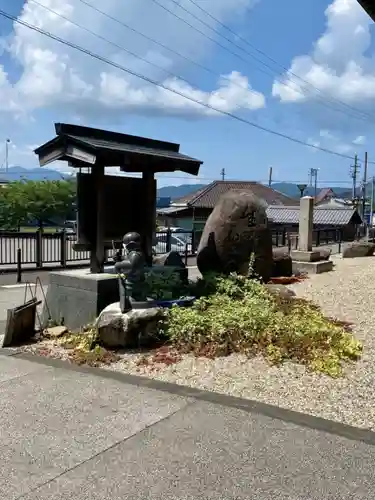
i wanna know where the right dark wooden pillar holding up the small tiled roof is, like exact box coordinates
[142,169,156,266]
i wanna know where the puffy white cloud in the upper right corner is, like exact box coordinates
[272,0,375,107]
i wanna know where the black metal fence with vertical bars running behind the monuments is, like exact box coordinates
[0,229,342,270]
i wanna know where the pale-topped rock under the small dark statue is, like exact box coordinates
[95,302,164,348]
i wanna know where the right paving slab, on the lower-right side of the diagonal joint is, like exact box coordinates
[24,401,375,500]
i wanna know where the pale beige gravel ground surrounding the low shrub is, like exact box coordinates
[21,257,375,430]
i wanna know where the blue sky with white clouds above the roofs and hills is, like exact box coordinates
[0,0,375,185]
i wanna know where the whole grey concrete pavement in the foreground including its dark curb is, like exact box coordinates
[0,356,375,500]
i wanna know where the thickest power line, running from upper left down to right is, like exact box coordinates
[0,9,375,164]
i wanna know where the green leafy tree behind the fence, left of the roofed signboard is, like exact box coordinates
[0,180,76,229]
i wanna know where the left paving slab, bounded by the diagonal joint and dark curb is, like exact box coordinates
[0,357,189,500]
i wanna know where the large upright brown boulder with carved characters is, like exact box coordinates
[197,191,273,282]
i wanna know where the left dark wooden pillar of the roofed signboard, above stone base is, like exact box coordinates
[90,164,105,273]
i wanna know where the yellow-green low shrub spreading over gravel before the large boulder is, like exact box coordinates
[164,275,362,376]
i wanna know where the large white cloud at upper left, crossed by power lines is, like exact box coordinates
[0,0,265,119]
